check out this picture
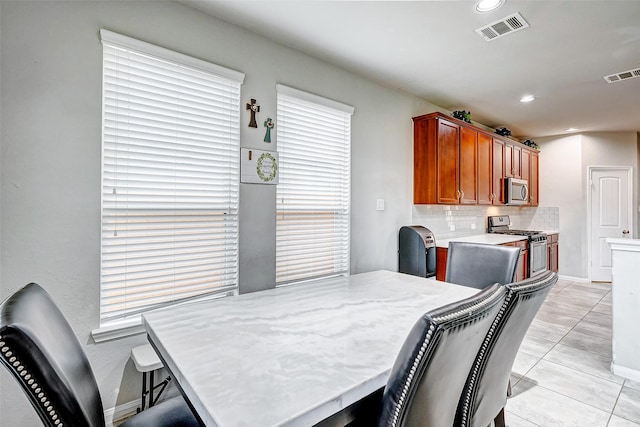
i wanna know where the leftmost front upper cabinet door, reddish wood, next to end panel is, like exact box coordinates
[436,120,460,205]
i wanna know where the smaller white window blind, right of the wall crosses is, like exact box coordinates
[276,85,353,284]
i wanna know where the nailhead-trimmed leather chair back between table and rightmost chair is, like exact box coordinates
[378,284,506,427]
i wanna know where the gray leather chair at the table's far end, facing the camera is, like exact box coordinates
[445,242,520,289]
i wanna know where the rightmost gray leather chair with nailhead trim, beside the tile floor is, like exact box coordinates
[455,271,558,427]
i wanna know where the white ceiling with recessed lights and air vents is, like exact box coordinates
[182,0,640,137]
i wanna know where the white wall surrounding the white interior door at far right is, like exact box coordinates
[536,132,638,279]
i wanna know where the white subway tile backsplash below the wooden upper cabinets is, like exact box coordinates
[412,205,560,240]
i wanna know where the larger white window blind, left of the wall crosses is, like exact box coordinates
[100,30,244,326]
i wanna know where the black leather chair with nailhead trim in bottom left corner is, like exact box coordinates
[0,283,200,427]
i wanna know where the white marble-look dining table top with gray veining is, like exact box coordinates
[143,271,477,427]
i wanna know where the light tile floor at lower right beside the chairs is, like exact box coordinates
[505,280,640,427]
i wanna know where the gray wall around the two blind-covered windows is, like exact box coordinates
[0,1,436,427]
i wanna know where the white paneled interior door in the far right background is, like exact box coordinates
[589,167,632,282]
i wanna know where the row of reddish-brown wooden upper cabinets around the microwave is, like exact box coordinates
[413,113,538,206]
